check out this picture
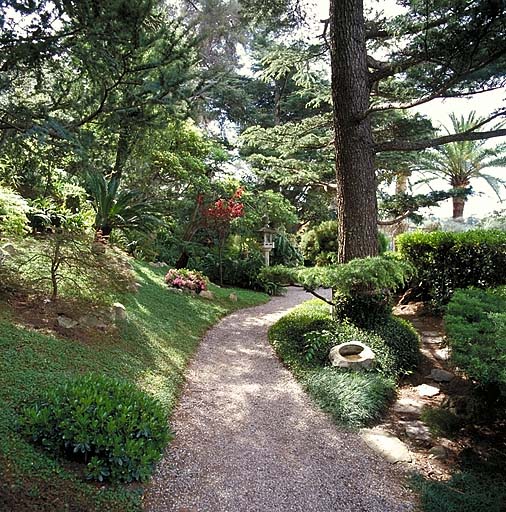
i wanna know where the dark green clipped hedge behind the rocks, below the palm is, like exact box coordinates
[396,230,506,306]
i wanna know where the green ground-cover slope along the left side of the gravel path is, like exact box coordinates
[0,264,267,512]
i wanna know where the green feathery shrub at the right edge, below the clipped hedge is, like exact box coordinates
[445,288,506,401]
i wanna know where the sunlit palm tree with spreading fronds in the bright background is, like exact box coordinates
[415,111,506,219]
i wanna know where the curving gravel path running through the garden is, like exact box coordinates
[145,289,413,512]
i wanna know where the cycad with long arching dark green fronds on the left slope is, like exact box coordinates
[88,173,162,237]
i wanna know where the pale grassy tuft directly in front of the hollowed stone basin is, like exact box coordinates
[305,367,395,427]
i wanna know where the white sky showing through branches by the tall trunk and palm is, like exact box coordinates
[308,0,506,217]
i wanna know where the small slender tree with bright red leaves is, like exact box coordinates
[198,187,244,285]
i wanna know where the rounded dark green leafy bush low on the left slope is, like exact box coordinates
[21,374,169,482]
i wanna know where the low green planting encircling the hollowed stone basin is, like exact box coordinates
[269,300,419,427]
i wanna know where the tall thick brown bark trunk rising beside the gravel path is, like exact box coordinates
[330,0,378,263]
